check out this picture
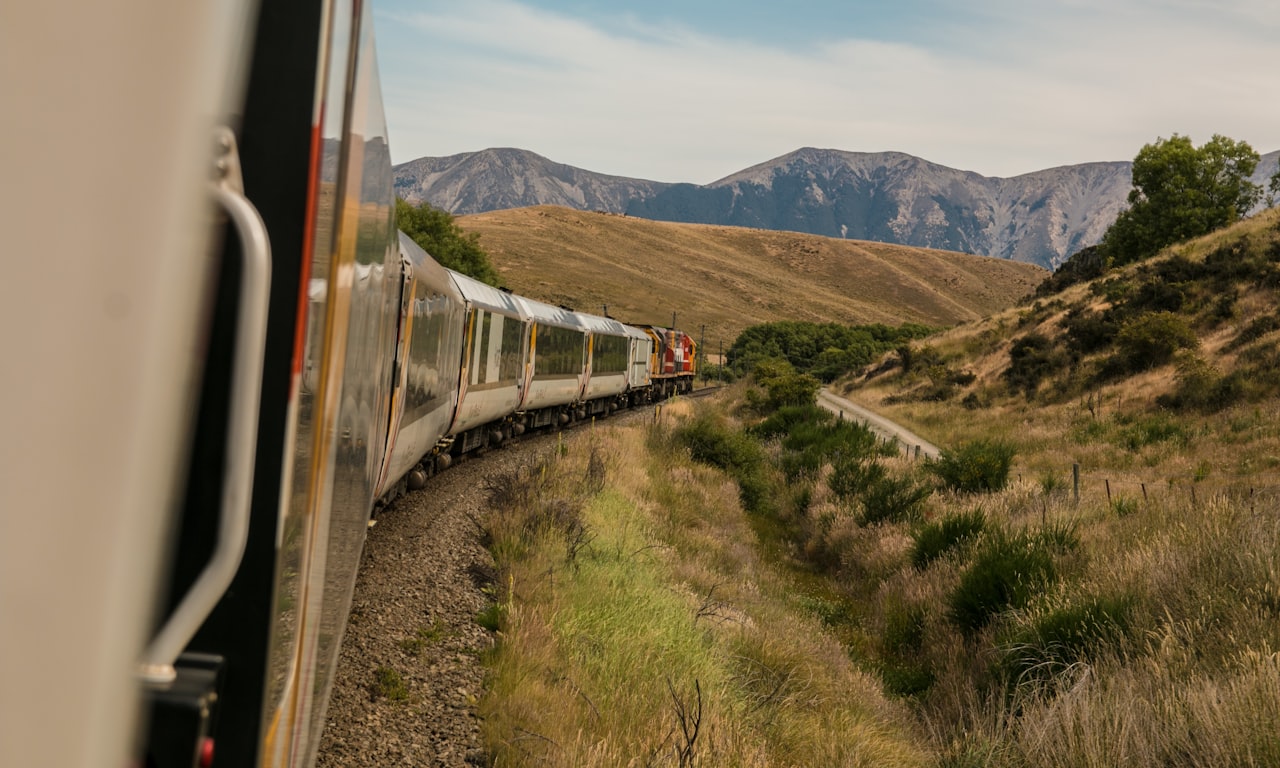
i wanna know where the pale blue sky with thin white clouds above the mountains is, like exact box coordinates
[374,0,1280,184]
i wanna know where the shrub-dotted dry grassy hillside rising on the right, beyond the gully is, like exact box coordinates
[806,210,1280,767]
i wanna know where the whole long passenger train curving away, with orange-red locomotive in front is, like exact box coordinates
[0,0,696,768]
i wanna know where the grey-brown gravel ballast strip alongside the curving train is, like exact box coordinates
[316,435,556,768]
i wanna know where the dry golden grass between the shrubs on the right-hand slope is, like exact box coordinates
[824,210,1280,767]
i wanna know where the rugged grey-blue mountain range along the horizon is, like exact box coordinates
[393,147,1280,269]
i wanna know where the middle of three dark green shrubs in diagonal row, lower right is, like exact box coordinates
[947,531,1055,635]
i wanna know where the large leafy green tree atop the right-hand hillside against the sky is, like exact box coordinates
[1102,133,1262,265]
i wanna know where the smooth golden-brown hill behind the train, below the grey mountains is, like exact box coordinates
[457,206,1047,348]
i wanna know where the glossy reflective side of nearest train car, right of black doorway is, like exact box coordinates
[260,0,403,765]
